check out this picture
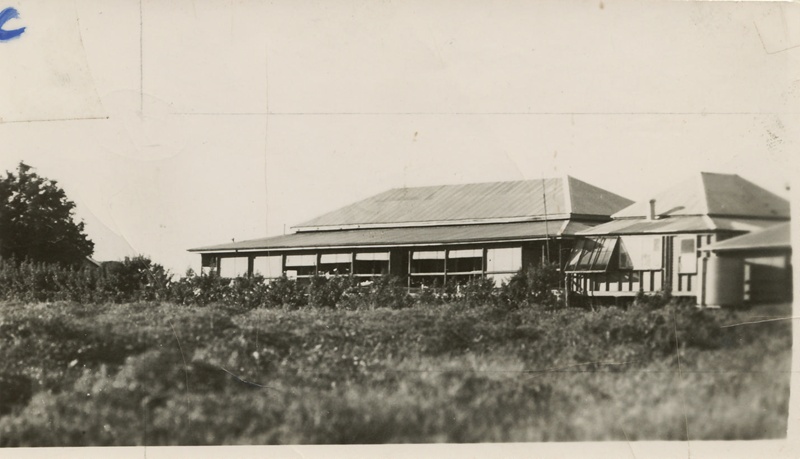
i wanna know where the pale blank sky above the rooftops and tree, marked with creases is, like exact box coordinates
[0,0,800,274]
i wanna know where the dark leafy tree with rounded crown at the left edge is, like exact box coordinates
[0,162,94,265]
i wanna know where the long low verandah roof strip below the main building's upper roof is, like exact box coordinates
[190,220,587,252]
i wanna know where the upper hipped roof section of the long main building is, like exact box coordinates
[294,177,632,232]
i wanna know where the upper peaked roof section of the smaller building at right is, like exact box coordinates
[612,172,789,219]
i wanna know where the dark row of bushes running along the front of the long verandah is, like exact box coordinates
[0,256,576,309]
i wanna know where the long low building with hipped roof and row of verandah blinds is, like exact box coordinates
[190,177,632,287]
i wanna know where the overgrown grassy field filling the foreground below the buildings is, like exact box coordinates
[0,303,791,446]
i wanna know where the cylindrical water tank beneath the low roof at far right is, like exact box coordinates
[705,257,744,307]
